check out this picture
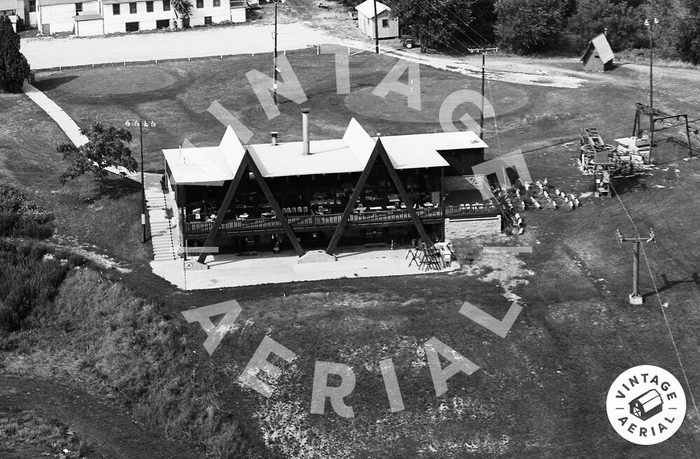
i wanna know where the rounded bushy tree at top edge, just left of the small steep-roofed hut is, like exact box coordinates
[496,0,568,53]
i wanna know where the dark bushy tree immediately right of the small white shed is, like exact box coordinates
[385,0,474,49]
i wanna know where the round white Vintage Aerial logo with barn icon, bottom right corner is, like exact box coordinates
[605,365,685,445]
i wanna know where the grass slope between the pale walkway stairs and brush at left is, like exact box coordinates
[0,94,152,263]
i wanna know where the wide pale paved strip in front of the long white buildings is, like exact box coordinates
[22,23,350,70]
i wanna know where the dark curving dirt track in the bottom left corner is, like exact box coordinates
[0,376,200,459]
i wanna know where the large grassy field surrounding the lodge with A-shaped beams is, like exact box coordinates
[0,48,700,458]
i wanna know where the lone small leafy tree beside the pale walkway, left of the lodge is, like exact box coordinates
[56,122,138,184]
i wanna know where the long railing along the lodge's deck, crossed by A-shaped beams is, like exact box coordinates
[187,205,500,235]
